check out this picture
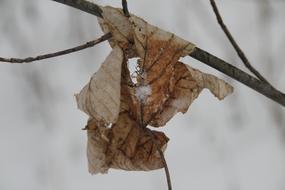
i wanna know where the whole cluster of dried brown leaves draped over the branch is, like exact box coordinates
[76,7,233,174]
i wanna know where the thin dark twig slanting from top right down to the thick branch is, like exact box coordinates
[210,0,272,86]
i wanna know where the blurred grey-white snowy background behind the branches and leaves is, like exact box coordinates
[0,0,285,190]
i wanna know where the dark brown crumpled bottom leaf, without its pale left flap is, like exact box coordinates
[108,113,168,171]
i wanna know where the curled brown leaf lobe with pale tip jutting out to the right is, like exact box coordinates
[150,62,233,127]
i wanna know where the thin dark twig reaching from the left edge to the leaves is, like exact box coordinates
[0,33,112,63]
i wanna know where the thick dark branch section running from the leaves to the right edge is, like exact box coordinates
[190,47,285,106]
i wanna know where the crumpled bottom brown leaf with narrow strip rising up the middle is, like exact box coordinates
[87,63,168,174]
